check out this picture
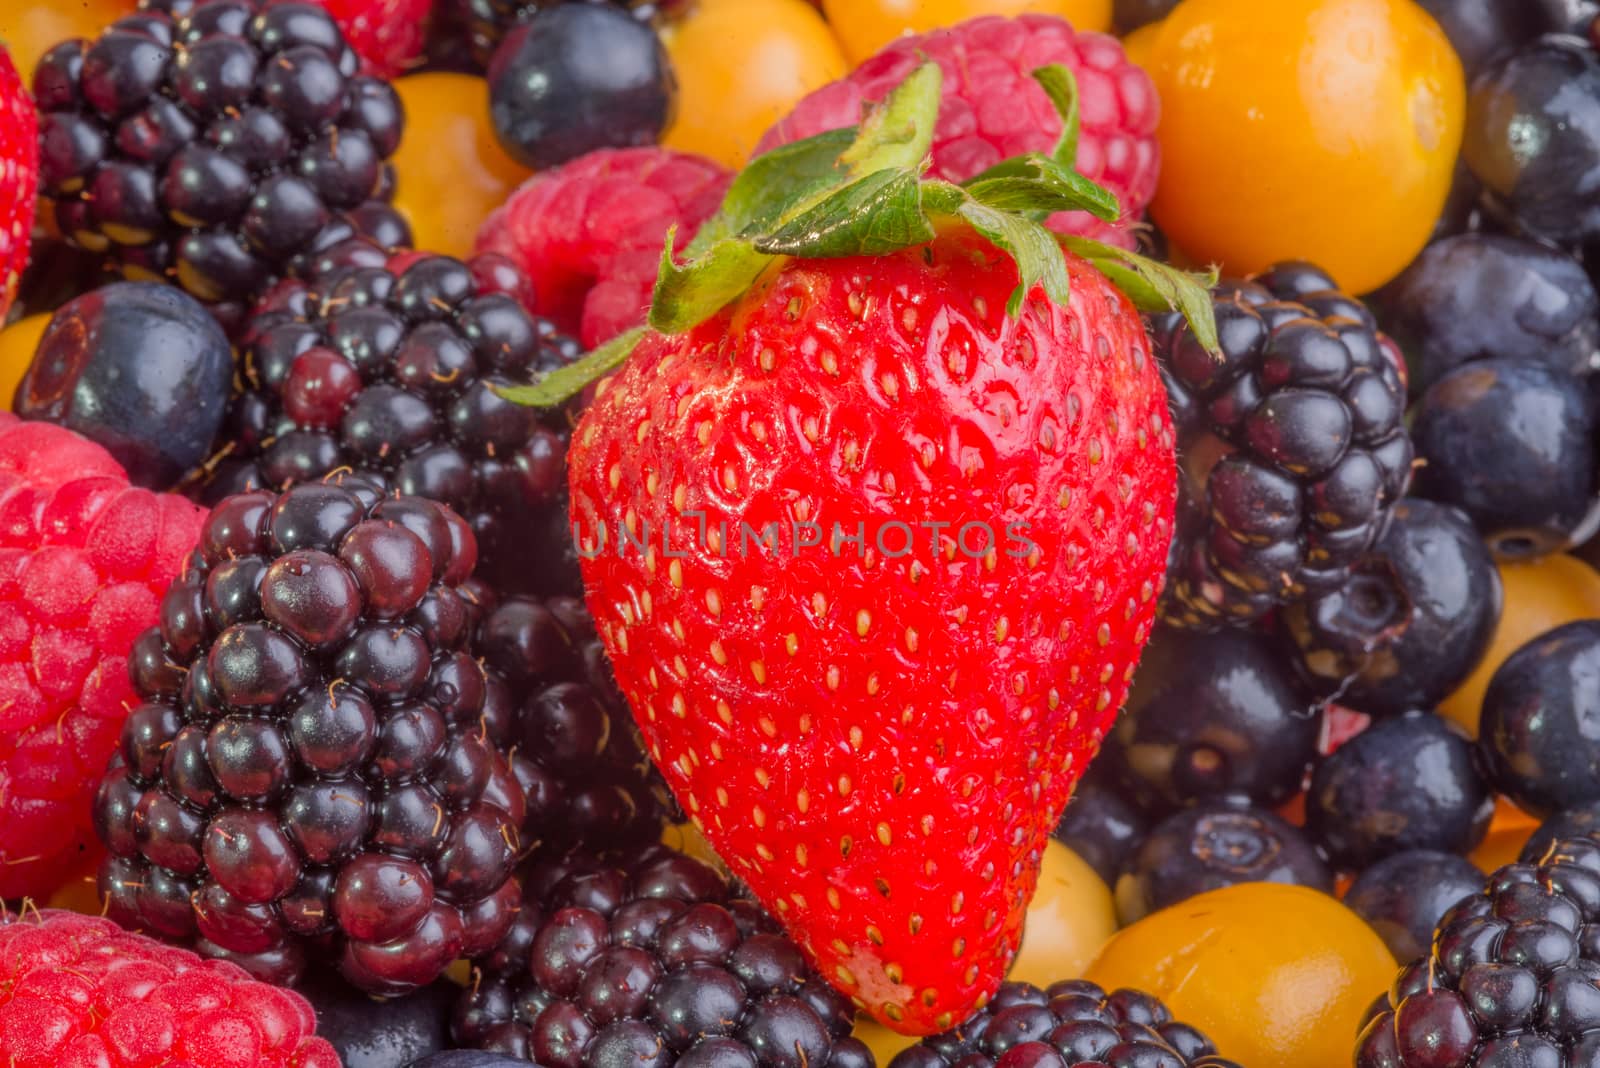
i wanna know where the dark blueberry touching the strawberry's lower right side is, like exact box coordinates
[1099,627,1322,811]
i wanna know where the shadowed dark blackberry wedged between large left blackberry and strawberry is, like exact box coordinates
[475,588,670,852]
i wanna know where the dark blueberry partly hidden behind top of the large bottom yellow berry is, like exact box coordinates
[1117,801,1333,924]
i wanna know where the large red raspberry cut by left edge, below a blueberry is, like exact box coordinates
[0,412,205,899]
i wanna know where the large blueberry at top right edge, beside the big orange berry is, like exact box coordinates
[1462,35,1600,245]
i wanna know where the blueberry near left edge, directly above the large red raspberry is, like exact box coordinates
[13,281,234,489]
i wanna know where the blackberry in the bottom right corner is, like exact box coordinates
[1355,838,1600,1068]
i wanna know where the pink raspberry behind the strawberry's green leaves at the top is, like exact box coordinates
[755,14,1160,248]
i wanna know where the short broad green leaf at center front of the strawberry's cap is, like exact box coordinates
[754,168,934,259]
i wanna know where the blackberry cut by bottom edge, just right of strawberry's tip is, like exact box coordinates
[890,980,1238,1068]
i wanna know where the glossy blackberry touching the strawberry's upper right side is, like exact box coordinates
[1152,264,1413,628]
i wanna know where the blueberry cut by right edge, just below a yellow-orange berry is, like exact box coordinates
[1478,619,1600,817]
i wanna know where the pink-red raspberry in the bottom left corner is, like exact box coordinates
[0,910,339,1068]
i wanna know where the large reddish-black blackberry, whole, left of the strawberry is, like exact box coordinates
[94,476,525,994]
